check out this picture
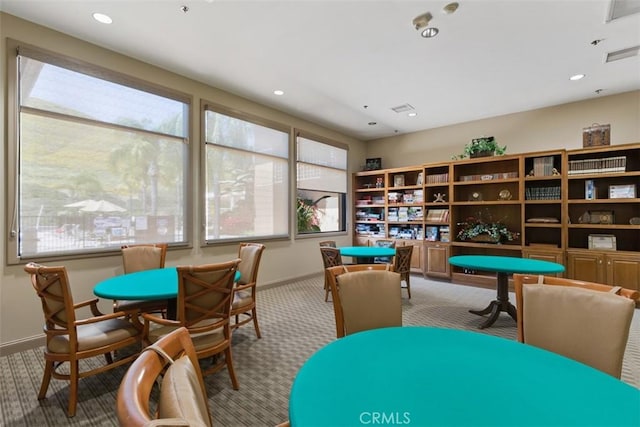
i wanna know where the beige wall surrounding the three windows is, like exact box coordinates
[0,13,365,353]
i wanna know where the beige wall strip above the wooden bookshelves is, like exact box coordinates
[367,91,640,168]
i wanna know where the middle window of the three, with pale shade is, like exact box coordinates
[204,105,289,243]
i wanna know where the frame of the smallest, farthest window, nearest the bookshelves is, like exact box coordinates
[292,129,350,239]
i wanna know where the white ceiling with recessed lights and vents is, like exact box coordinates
[0,0,640,140]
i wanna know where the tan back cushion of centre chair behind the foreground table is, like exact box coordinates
[338,270,402,334]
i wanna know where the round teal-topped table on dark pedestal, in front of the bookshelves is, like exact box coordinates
[449,255,564,329]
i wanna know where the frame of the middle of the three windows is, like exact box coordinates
[199,99,294,247]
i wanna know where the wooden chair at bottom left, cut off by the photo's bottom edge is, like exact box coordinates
[116,328,212,427]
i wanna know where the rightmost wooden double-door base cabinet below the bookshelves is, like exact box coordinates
[567,249,640,291]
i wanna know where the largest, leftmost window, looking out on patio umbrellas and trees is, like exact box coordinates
[9,47,190,259]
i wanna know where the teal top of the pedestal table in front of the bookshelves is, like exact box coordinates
[449,255,564,274]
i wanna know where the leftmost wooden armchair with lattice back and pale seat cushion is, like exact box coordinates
[24,263,142,417]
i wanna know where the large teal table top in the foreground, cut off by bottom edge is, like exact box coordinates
[289,326,640,427]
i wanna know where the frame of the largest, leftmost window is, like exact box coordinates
[5,38,193,265]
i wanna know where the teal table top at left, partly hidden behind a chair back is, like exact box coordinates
[93,267,240,300]
